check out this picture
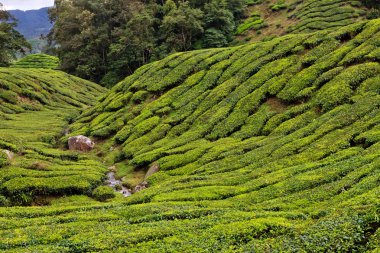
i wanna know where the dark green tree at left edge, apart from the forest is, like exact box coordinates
[0,3,31,66]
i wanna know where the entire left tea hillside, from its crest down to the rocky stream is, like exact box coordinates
[0,68,105,206]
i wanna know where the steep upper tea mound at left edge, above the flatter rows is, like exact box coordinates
[0,68,105,114]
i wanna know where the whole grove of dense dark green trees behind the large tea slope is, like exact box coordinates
[50,0,244,86]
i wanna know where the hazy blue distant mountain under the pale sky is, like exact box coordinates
[9,8,53,39]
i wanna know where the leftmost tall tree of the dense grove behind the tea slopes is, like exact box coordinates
[49,0,110,82]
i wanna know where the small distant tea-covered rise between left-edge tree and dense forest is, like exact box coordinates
[11,54,59,69]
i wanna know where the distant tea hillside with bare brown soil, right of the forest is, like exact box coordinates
[237,0,372,41]
